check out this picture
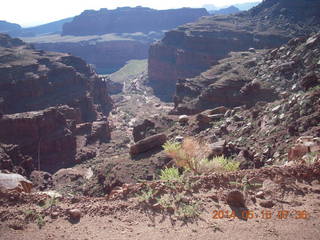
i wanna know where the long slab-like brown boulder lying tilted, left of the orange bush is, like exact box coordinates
[130,133,167,156]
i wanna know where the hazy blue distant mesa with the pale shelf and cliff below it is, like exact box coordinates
[18,7,208,74]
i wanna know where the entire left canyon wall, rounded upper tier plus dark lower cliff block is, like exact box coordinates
[0,35,112,175]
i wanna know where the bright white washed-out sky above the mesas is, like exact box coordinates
[0,0,259,27]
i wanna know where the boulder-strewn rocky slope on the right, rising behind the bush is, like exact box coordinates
[174,34,320,169]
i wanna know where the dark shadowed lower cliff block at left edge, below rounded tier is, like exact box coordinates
[0,108,76,173]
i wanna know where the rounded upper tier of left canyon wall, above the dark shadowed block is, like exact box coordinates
[0,35,111,118]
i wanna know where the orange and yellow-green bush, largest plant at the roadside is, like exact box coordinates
[163,138,239,174]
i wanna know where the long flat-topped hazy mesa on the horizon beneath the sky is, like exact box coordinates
[62,7,208,36]
